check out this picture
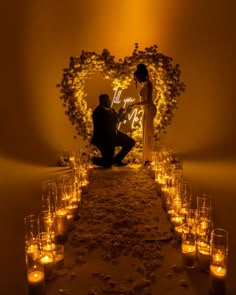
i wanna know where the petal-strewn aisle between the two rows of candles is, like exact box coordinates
[47,166,208,295]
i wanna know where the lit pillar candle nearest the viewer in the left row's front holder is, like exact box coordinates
[27,271,45,295]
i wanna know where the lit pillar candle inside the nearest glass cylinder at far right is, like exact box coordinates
[210,265,227,295]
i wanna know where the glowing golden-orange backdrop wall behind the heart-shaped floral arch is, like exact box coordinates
[0,0,236,164]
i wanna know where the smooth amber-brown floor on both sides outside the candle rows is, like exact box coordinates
[0,159,236,295]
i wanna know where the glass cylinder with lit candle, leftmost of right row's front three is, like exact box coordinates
[182,224,196,268]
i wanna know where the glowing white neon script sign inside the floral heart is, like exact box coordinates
[111,88,143,129]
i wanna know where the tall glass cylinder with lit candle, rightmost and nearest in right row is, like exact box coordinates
[209,228,228,295]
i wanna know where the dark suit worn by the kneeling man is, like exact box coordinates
[91,105,135,168]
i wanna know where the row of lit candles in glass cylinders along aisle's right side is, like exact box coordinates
[150,146,228,295]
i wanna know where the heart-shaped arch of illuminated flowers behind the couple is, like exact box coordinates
[57,43,185,161]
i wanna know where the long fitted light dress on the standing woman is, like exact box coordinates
[140,80,157,163]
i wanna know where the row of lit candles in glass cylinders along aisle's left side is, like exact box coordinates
[24,152,93,295]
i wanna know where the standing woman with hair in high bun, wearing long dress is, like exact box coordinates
[131,64,157,167]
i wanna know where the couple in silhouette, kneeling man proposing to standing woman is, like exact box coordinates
[91,64,157,168]
